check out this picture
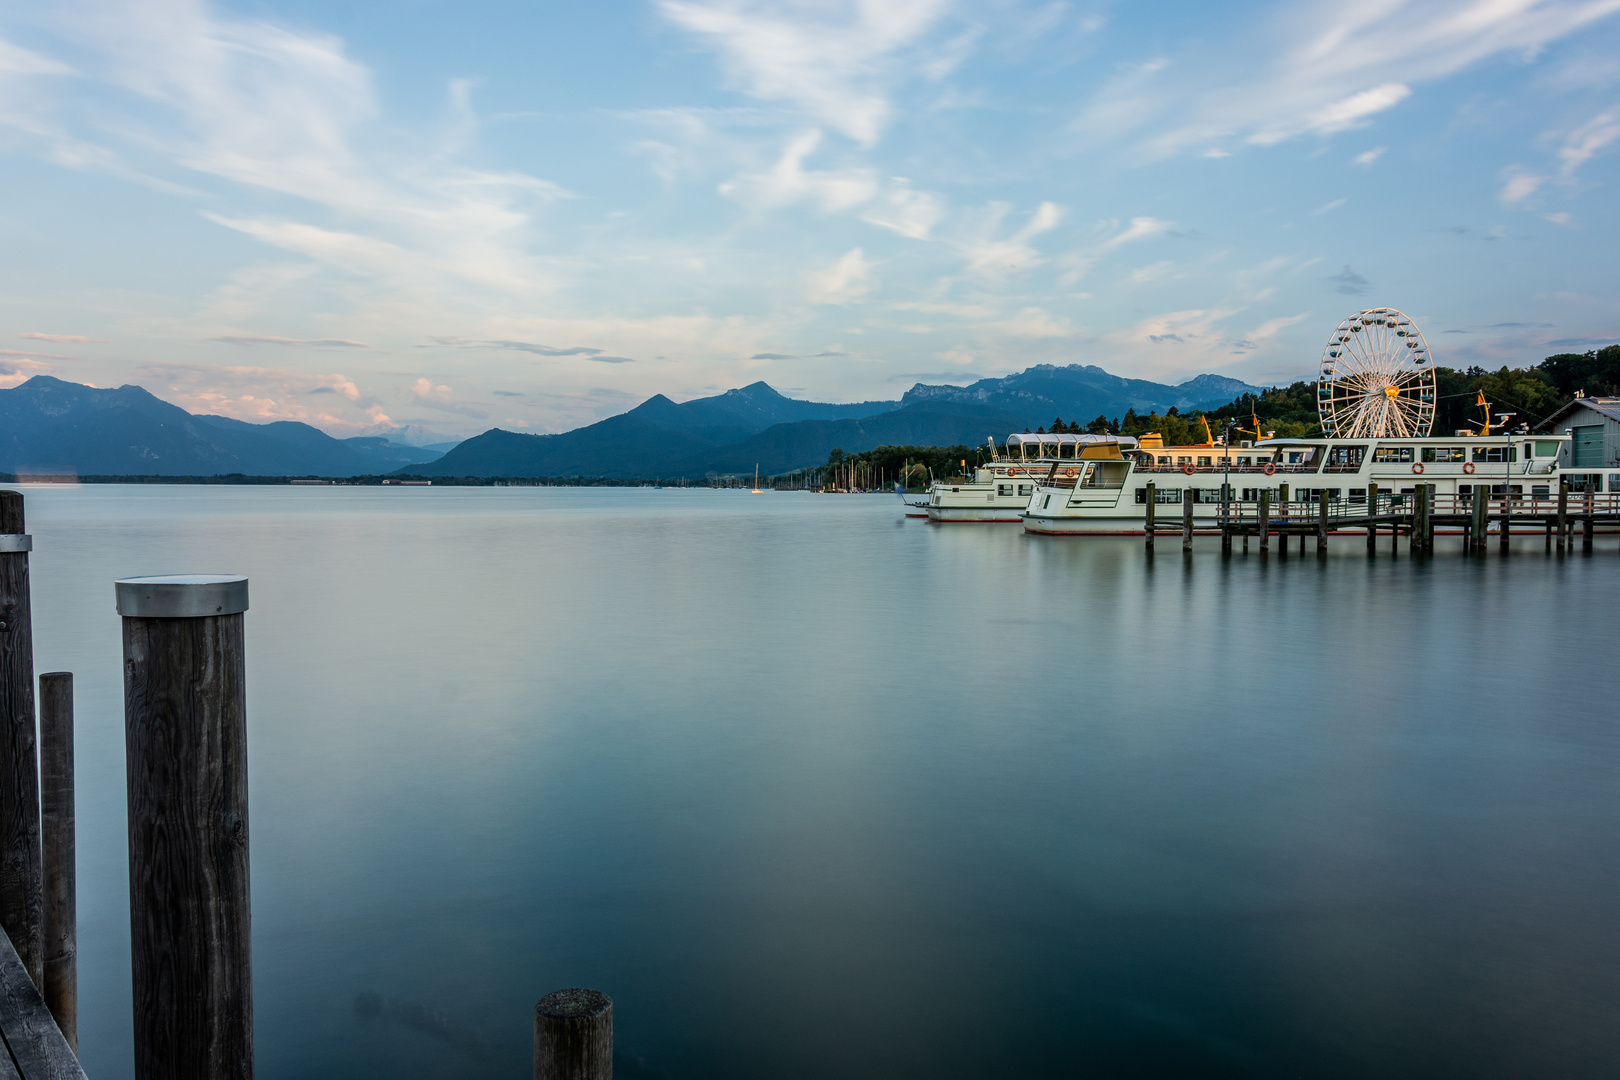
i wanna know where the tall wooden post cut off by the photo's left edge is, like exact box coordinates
[0,491,45,986]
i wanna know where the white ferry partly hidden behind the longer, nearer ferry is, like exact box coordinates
[928,434,1136,521]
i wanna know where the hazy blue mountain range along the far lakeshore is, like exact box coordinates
[0,364,1259,479]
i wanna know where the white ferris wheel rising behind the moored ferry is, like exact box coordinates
[1317,308,1434,439]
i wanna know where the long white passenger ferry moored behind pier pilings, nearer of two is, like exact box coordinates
[1017,432,1574,536]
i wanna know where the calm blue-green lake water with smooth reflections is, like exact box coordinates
[12,487,1620,1080]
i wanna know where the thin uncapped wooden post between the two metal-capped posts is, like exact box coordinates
[39,672,79,1054]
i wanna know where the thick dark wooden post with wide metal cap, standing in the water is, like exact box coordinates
[117,575,253,1080]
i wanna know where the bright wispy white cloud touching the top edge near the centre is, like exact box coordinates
[658,0,946,146]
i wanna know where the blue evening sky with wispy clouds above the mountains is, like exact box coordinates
[0,0,1620,437]
